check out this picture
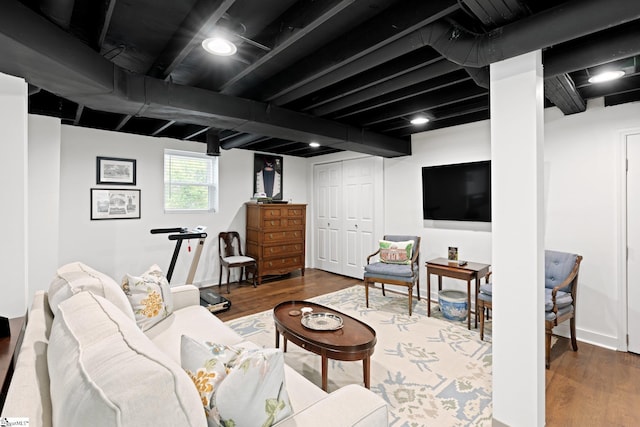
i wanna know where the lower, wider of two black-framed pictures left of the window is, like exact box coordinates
[91,188,140,220]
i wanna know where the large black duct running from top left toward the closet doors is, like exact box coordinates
[0,0,411,157]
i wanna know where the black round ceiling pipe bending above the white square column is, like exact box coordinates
[419,0,640,68]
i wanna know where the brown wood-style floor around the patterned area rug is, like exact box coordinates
[206,269,640,427]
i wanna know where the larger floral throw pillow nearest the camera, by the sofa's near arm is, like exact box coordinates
[180,335,292,427]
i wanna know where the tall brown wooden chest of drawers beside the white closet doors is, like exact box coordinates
[247,203,307,284]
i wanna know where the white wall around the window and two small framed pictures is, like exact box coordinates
[52,126,307,288]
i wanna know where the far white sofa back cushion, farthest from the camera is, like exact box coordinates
[48,262,135,320]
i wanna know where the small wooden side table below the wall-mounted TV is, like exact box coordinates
[426,258,491,329]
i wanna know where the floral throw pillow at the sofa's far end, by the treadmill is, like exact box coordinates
[122,264,173,331]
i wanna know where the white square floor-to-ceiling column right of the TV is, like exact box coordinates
[490,51,545,427]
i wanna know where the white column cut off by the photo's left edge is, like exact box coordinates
[0,74,28,318]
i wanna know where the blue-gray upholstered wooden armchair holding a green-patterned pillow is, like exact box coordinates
[364,235,420,316]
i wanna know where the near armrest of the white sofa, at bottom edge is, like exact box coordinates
[276,384,389,427]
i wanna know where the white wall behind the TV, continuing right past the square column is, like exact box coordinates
[402,100,640,348]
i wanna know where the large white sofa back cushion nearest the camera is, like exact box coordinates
[47,292,207,427]
